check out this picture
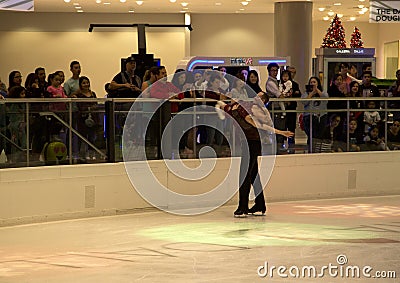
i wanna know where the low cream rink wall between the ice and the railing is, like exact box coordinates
[0,151,400,226]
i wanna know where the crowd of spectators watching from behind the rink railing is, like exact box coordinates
[0,57,400,165]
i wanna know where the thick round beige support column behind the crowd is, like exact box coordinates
[274,1,313,93]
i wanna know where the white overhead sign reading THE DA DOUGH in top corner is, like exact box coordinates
[369,0,400,23]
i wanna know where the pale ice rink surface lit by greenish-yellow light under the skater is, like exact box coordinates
[0,196,400,283]
